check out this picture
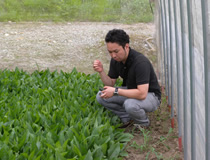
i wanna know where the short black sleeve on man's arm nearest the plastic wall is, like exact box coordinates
[135,61,150,85]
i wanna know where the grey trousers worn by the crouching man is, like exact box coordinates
[96,87,160,126]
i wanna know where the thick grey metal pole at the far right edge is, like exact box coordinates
[201,0,210,160]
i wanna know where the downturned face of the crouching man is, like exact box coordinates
[106,42,129,63]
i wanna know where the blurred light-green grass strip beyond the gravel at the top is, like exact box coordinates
[0,0,154,23]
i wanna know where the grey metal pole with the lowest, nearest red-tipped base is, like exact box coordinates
[173,0,182,151]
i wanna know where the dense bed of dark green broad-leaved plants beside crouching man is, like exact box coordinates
[0,68,132,160]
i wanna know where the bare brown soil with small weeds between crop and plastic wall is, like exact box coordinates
[124,91,184,160]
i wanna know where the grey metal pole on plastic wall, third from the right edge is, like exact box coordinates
[179,0,188,160]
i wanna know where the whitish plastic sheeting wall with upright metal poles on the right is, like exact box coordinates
[155,0,210,160]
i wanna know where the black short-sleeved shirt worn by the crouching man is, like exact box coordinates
[108,48,161,99]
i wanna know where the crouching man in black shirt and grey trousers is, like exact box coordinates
[93,29,161,128]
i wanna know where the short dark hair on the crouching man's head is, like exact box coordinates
[105,29,130,48]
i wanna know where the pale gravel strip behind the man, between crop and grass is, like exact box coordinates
[0,22,155,74]
